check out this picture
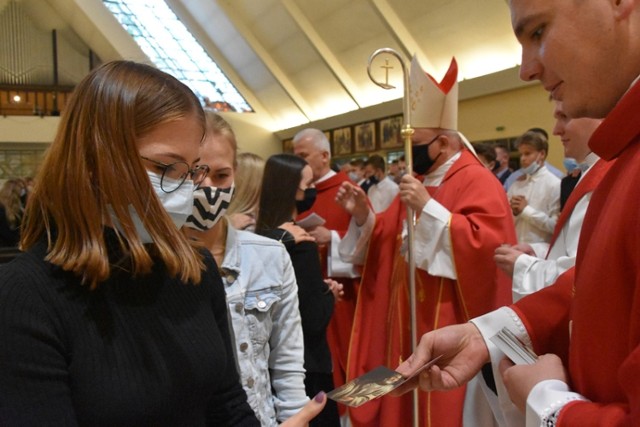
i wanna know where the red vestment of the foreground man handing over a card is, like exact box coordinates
[514,84,640,427]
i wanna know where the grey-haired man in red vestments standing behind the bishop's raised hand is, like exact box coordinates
[293,128,360,420]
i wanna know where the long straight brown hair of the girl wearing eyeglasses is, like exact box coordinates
[21,61,205,288]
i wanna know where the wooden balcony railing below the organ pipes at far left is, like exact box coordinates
[0,85,73,116]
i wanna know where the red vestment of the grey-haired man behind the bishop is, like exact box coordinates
[296,172,358,402]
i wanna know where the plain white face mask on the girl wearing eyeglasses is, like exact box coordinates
[109,171,193,243]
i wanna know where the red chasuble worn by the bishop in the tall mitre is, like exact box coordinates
[349,151,516,426]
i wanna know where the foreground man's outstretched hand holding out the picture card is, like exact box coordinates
[394,323,489,394]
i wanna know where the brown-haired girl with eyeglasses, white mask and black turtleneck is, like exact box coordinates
[0,61,322,426]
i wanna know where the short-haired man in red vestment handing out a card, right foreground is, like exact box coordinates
[398,0,640,426]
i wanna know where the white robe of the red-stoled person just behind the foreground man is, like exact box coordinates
[513,153,599,302]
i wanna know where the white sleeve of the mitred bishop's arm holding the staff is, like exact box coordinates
[415,199,458,280]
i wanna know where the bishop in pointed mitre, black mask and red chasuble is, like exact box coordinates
[338,58,516,427]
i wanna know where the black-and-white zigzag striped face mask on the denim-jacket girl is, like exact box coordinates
[185,184,234,231]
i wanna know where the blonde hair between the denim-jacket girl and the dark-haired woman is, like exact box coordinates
[227,153,264,218]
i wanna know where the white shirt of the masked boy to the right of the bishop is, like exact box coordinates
[507,166,560,247]
